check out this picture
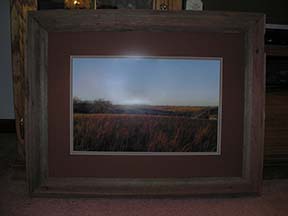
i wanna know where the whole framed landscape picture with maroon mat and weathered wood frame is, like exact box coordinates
[25,10,265,196]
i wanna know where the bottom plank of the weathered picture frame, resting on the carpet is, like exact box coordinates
[33,178,253,197]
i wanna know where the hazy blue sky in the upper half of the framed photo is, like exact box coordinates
[72,57,221,106]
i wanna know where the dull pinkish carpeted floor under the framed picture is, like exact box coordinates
[0,170,288,216]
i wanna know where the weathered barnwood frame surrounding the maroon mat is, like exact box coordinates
[25,10,265,197]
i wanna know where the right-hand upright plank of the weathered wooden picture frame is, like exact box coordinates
[243,14,265,193]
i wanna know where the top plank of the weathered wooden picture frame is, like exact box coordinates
[31,9,262,32]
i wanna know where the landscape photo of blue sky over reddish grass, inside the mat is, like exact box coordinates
[71,57,221,153]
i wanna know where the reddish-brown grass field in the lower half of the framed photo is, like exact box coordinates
[73,113,217,152]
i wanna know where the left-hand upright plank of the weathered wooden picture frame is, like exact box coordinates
[25,14,48,192]
